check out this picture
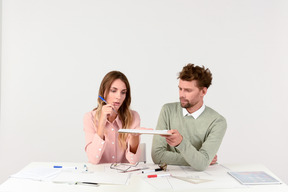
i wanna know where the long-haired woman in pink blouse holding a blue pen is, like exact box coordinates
[84,71,140,164]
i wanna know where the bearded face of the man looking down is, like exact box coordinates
[178,79,207,109]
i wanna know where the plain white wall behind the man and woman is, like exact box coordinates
[0,0,288,183]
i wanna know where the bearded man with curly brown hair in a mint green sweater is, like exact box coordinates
[152,64,227,171]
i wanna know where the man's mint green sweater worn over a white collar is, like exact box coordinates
[151,102,227,171]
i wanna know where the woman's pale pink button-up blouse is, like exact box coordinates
[84,110,140,164]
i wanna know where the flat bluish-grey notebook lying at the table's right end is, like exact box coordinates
[228,171,281,185]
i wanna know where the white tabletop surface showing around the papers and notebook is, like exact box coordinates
[0,162,288,192]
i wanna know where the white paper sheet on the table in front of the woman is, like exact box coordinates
[52,172,130,185]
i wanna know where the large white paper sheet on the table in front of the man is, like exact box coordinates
[143,164,245,190]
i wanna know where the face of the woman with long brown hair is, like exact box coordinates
[106,79,127,111]
